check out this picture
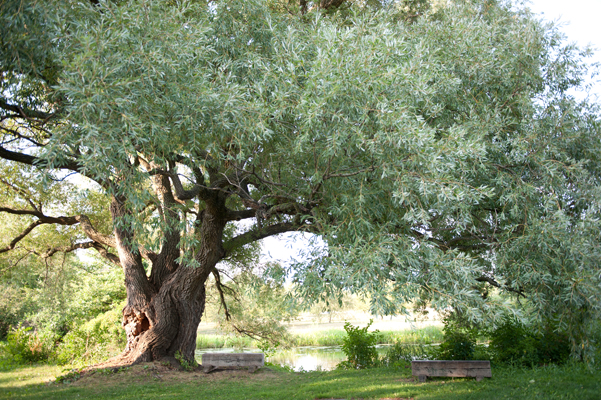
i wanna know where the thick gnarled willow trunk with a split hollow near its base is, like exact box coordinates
[106,194,226,364]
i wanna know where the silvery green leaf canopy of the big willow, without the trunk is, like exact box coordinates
[5,1,601,360]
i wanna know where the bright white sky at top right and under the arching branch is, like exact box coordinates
[261,0,601,263]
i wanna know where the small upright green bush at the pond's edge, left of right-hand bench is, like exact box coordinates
[339,320,379,369]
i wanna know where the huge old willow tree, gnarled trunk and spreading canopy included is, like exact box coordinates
[0,0,601,362]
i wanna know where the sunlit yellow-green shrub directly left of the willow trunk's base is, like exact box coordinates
[55,307,126,365]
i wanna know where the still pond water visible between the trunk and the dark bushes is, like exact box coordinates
[196,344,389,371]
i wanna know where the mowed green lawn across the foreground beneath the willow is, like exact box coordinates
[0,363,601,400]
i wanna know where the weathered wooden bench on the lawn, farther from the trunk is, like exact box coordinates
[411,360,492,382]
